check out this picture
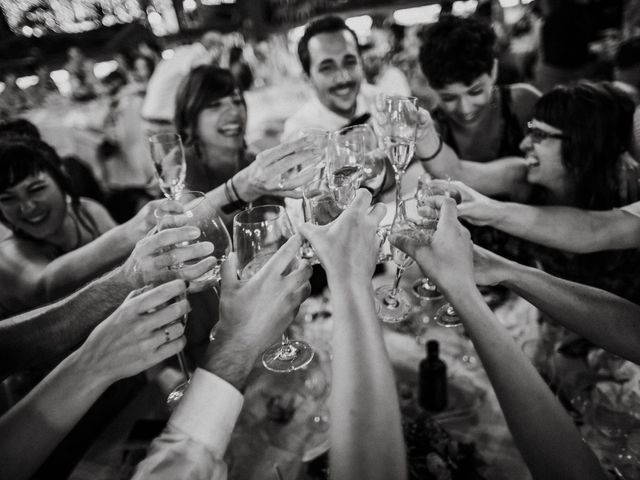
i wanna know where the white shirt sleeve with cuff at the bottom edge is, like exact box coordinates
[133,369,243,480]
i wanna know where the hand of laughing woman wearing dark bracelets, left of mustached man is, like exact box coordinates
[233,138,319,202]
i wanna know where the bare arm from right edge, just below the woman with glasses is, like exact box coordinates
[454,182,640,253]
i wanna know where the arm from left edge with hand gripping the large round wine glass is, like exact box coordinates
[0,227,214,378]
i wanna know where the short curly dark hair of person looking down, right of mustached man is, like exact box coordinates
[419,15,496,88]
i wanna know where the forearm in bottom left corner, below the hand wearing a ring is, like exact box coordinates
[0,351,109,480]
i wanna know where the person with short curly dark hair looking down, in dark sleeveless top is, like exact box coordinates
[416,15,540,196]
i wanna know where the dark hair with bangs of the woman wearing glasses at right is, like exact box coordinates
[534,81,635,210]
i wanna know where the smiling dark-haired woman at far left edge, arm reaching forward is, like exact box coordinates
[0,137,156,318]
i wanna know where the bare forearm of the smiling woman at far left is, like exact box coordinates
[41,224,135,300]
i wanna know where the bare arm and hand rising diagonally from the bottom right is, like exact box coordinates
[391,197,606,480]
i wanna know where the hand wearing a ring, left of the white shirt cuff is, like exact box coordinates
[78,280,190,385]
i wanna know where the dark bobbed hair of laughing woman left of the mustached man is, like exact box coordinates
[173,65,246,146]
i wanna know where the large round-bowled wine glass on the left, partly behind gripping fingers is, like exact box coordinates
[154,191,231,405]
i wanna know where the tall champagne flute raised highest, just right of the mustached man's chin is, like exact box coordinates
[376,95,418,210]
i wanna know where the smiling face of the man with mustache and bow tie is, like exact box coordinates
[308,30,363,118]
